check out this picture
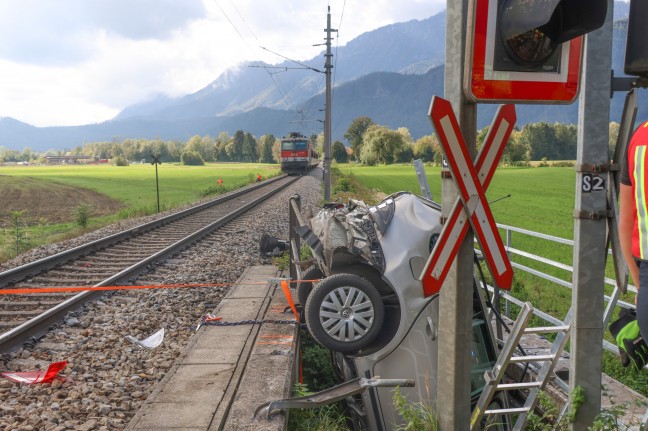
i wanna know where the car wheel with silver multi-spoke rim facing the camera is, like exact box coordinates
[304,274,385,353]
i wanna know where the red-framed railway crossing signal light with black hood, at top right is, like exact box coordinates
[464,0,608,103]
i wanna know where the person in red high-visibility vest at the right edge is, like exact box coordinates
[617,121,648,368]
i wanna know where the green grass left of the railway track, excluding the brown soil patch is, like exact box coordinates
[0,163,281,262]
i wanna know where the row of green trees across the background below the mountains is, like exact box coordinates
[0,117,619,165]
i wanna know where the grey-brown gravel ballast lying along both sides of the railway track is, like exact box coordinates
[0,169,322,430]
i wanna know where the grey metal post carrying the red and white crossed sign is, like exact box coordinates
[436,0,476,431]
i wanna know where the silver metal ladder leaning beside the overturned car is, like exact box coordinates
[470,302,571,431]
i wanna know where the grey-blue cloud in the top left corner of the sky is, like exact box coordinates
[0,0,206,66]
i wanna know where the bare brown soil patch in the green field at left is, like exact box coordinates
[0,175,124,225]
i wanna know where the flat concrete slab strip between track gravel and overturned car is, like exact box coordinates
[127,267,297,431]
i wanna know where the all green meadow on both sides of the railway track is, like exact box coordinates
[0,163,648,394]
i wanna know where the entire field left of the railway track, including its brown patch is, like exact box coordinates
[0,163,280,262]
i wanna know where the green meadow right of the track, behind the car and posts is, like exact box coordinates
[333,164,648,396]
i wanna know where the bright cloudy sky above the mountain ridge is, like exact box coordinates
[0,0,446,127]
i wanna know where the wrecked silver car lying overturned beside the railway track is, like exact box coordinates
[284,192,504,430]
